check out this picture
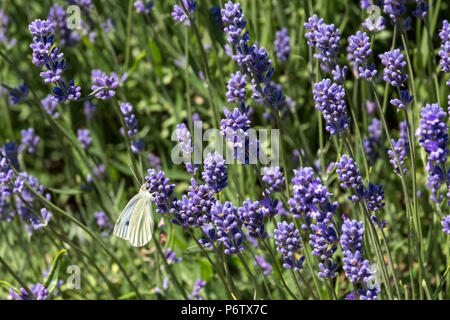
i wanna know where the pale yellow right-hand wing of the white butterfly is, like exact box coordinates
[128,193,154,247]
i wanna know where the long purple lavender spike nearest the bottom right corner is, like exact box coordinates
[340,216,372,283]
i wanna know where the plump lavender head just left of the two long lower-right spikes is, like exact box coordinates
[273,221,305,271]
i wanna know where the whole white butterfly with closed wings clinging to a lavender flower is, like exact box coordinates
[114,185,154,247]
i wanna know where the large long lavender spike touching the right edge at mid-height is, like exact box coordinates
[416,104,450,203]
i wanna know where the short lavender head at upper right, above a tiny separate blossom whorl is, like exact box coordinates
[378,49,408,87]
